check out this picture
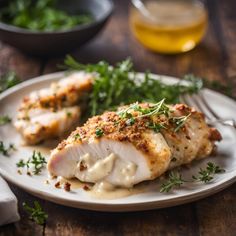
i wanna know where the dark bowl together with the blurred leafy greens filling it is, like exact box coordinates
[0,0,113,56]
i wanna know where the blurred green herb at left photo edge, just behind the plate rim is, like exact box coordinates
[0,71,21,93]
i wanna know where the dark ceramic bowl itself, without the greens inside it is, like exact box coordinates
[0,0,113,56]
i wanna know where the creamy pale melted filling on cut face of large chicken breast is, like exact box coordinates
[75,153,137,188]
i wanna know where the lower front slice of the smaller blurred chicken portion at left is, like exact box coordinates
[15,106,81,144]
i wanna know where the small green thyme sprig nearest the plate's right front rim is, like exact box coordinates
[192,162,225,183]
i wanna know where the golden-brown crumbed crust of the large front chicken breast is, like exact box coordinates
[57,103,219,173]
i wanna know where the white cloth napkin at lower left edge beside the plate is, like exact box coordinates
[0,176,20,225]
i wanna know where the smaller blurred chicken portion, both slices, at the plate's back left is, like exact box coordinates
[14,72,93,144]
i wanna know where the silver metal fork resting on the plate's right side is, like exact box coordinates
[181,91,236,129]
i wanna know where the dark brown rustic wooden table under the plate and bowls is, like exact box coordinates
[0,0,236,236]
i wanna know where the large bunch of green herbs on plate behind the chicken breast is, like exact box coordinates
[63,56,202,117]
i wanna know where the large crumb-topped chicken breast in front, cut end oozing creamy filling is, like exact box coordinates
[47,101,221,187]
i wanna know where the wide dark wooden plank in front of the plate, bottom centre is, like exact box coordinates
[42,201,199,236]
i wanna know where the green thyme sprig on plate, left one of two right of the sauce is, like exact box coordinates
[160,171,186,193]
